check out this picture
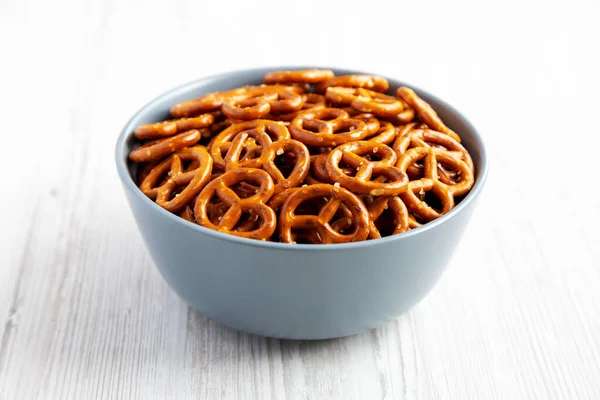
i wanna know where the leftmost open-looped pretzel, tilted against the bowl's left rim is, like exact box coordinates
[140,146,213,213]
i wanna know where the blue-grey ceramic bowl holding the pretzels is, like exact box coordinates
[116,67,487,339]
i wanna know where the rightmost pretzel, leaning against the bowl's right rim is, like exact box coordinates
[397,147,475,196]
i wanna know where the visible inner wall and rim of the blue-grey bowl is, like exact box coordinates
[116,66,488,250]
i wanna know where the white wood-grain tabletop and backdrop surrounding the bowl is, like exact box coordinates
[0,0,600,400]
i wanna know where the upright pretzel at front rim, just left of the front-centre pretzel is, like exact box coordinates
[194,168,277,240]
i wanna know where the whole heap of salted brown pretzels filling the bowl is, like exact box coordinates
[129,69,474,244]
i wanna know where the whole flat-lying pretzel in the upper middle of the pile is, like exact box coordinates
[290,108,369,147]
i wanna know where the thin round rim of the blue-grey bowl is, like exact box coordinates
[115,65,489,251]
